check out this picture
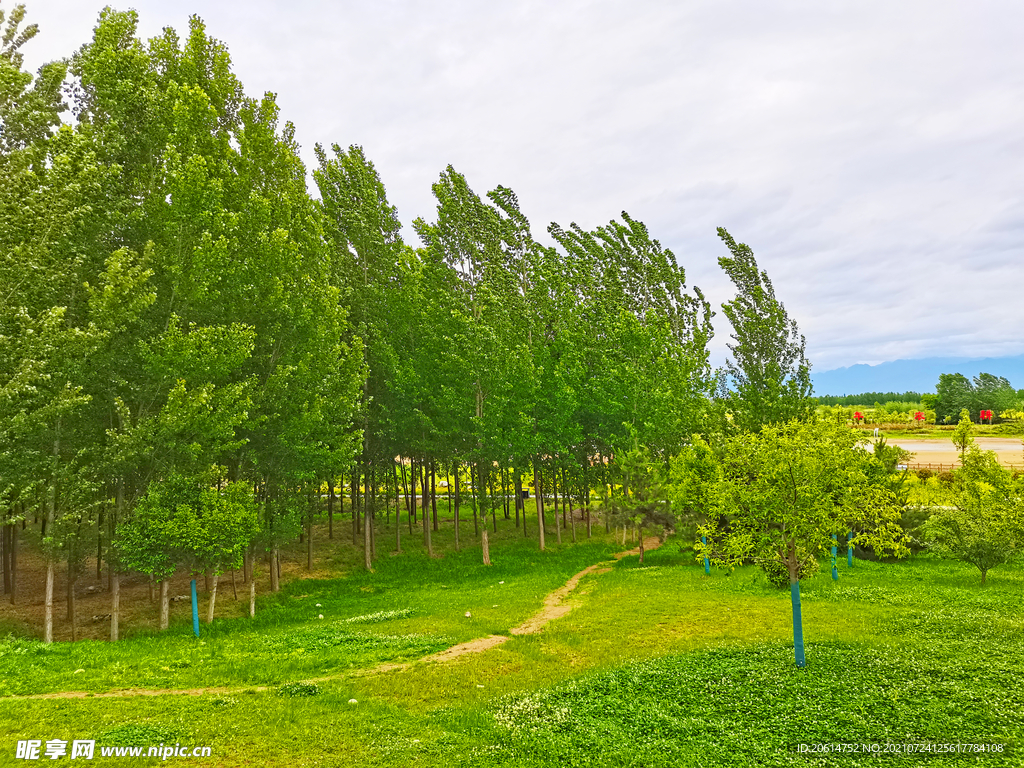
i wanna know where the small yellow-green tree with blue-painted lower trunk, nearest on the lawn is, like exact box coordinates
[679,422,906,667]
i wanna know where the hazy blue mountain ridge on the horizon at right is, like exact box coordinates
[811,354,1024,395]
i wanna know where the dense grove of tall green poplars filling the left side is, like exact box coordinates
[0,6,733,640]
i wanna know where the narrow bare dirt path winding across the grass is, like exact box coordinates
[22,537,662,699]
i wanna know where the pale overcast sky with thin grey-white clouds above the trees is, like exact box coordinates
[16,0,1024,371]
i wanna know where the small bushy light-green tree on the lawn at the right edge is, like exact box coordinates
[923,445,1024,584]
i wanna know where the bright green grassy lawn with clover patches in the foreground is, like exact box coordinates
[0,520,1024,767]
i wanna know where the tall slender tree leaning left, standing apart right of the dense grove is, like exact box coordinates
[718,227,813,431]
